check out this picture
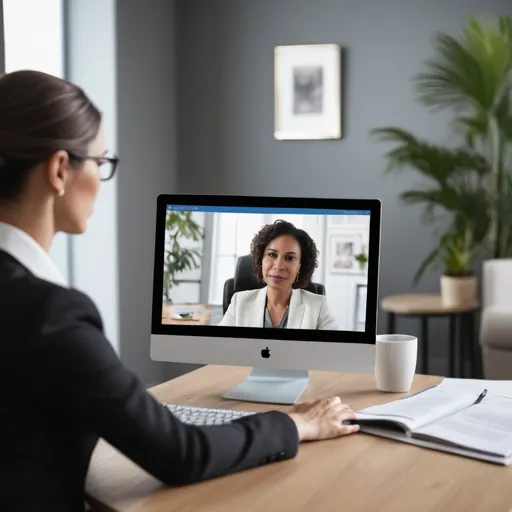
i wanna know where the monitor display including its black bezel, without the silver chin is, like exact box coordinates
[153,196,380,343]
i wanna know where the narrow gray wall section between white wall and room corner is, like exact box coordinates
[116,0,199,385]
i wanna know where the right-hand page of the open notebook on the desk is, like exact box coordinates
[414,397,512,457]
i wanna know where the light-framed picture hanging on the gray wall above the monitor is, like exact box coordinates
[274,44,342,140]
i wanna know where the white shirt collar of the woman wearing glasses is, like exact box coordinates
[0,222,68,287]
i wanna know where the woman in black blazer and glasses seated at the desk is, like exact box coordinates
[0,71,357,512]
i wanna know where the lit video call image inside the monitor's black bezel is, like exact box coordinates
[162,205,370,331]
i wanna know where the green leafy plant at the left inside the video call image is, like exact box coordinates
[163,210,204,303]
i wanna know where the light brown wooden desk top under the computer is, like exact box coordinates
[87,366,512,512]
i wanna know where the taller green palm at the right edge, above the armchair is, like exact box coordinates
[415,16,512,258]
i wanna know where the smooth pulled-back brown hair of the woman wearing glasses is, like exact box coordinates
[0,71,101,201]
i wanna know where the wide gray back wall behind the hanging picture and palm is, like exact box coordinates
[177,0,512,371]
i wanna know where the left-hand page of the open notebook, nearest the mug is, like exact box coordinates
[356,386,482,430]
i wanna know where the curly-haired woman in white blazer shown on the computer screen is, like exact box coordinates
[219,220,338,330]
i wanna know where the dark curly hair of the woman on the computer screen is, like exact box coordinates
[251,220,318,288]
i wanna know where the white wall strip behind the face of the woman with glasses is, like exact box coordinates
[65,0,118,351]
